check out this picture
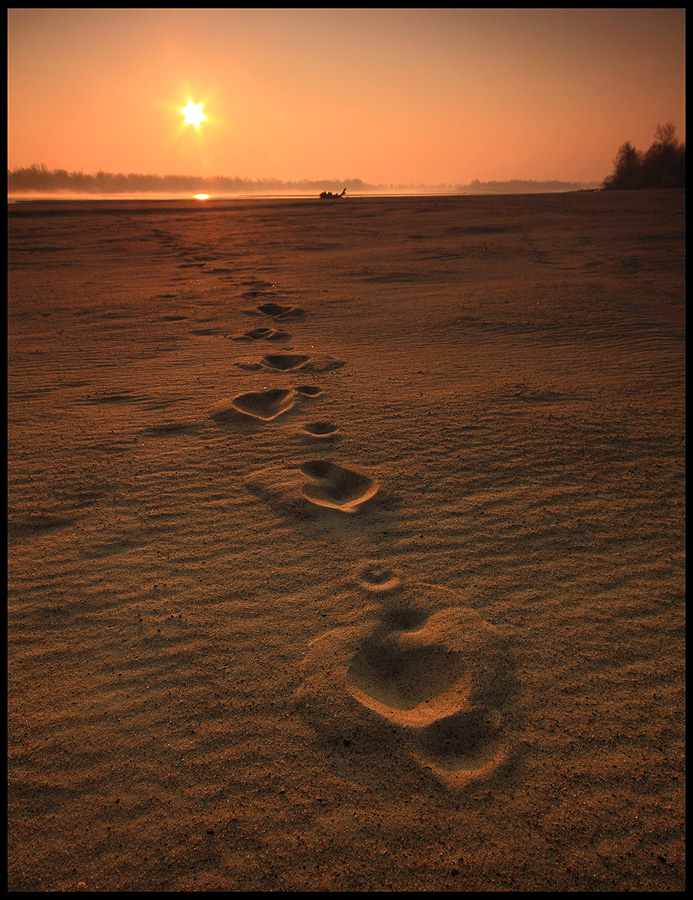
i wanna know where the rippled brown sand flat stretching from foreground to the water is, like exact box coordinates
[8,191,685,891]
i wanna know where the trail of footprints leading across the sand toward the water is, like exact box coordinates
[205,282,511,787]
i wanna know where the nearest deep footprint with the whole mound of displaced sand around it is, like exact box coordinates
[296,585,513,787]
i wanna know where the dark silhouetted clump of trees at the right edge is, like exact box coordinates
[604,122,686,191]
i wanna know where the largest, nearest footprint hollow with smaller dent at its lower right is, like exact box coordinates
[356,606,508,782]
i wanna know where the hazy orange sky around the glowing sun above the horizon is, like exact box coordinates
[8,9,686,184]
